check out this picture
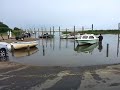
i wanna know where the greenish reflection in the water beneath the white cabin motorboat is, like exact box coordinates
[74,43,98,53]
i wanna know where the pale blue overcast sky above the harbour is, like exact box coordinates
[0,0,120,29]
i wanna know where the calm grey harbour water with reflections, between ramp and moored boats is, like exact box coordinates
[9,33,120,66]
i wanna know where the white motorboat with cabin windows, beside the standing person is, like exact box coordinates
[75,34,99,45]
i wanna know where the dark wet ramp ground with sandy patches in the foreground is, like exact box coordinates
[0,62,120,90]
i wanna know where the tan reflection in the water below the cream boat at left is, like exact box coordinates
[13,47,38,57]
